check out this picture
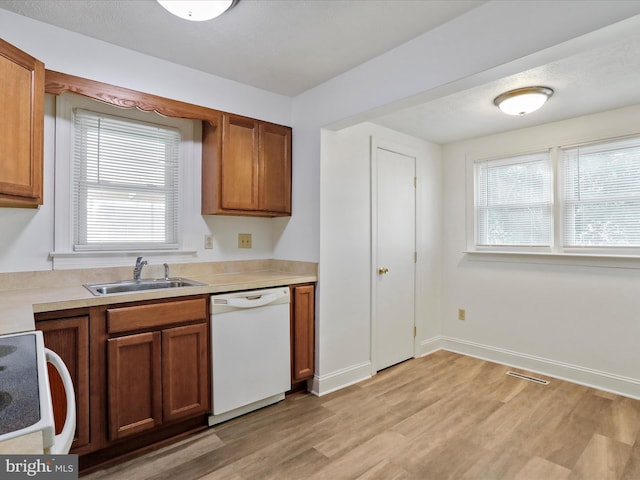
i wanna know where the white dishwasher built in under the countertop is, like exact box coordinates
[209,287,291,426]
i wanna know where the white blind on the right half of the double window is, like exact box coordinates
[561,137,640,247]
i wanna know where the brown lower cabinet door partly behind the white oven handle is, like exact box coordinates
[36,316,89,449]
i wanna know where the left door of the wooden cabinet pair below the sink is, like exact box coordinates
[107,332,162,440]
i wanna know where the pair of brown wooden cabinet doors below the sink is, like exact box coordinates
[107,323,209,440]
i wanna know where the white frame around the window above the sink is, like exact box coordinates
[51,92,196,268]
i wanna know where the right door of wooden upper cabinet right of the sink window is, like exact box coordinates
[259,123,291,215]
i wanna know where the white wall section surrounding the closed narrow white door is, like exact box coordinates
[314,123,442,393]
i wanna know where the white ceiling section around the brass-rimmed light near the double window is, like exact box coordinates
[375,26,640,144]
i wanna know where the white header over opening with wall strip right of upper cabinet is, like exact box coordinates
[284,0,640,261]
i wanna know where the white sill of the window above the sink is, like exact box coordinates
[49,250,198,270]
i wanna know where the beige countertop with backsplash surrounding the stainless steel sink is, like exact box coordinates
[0,260,317,334]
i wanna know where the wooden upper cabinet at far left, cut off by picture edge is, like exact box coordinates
[0,40,44,207]
